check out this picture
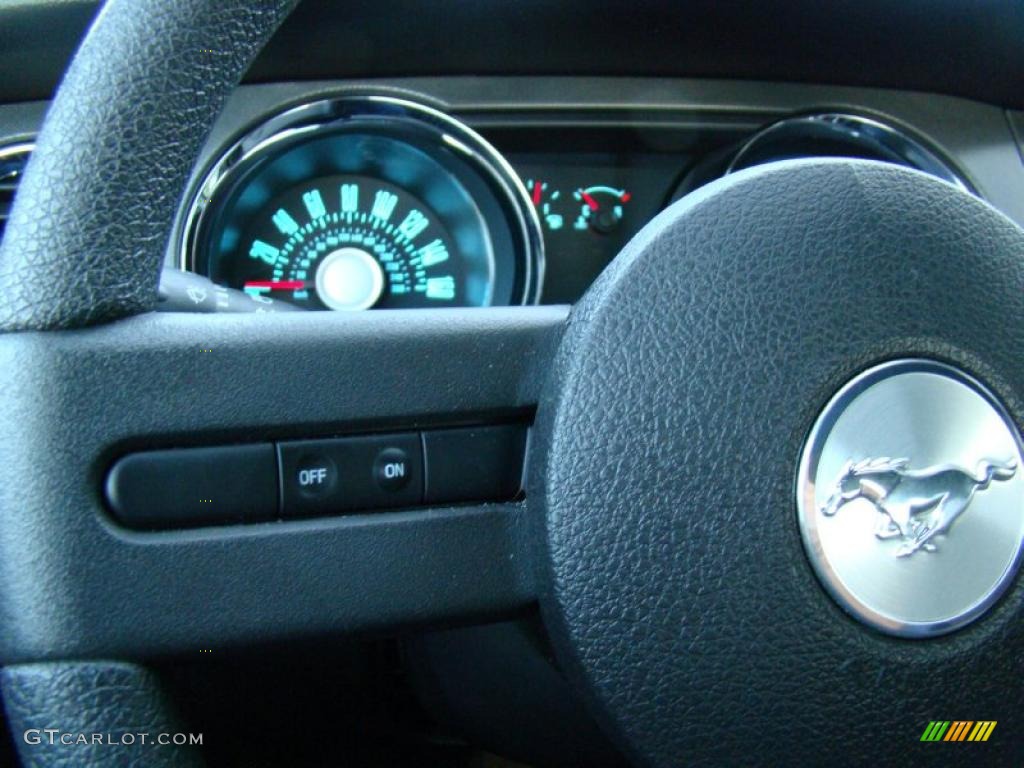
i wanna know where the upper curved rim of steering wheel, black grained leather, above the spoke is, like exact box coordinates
[0,0,297,331]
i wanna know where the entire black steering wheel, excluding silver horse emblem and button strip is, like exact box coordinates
[0,0,1024,766]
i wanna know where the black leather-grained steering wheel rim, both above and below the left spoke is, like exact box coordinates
[0,0,296,766]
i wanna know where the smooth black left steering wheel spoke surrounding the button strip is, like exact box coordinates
[0,307,566,663]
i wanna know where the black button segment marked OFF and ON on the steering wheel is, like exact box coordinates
[278,433,423,518]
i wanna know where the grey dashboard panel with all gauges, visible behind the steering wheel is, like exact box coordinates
[8,78,1024,311]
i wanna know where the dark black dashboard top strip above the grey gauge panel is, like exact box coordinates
[6,0,1024,106]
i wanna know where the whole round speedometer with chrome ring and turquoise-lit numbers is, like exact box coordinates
[182,96,543,310]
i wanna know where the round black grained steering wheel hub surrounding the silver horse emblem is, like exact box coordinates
[527,161,1024,766]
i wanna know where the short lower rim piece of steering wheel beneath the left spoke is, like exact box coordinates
[0,662,204,768]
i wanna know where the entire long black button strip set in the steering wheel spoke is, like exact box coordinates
[104,425,527,529]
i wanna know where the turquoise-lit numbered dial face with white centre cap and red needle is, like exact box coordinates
[224,175,471,310]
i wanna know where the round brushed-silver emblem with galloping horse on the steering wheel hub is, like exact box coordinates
[797,359,1024,638]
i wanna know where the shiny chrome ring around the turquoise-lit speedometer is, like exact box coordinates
[177,94,545,305]
